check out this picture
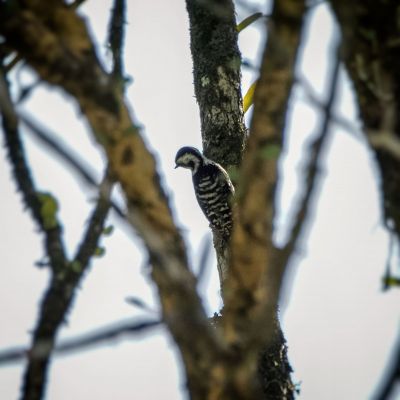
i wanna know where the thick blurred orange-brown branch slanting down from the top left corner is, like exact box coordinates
[0,2,222,398]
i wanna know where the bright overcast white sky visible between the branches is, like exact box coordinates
[0,0,400,400]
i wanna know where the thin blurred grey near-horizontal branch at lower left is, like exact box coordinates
[0,319,161,366]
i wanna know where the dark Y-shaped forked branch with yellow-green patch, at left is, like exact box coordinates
[0,59,111,400]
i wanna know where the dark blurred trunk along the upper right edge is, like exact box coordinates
[331,0,400,238]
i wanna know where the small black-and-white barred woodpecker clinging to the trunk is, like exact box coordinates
[175,147,235,238]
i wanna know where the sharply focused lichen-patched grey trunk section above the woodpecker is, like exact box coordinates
[186,0,246,170]
